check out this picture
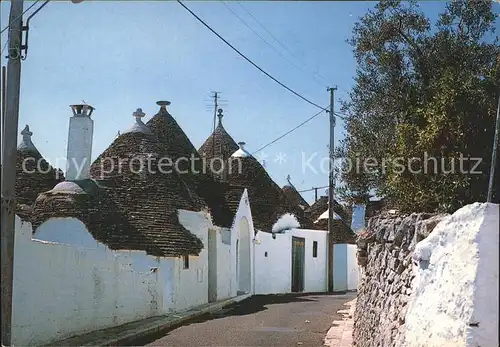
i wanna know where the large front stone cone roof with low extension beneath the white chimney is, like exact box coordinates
[34,132,203,256]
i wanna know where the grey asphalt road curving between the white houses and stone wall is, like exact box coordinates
[133,293,355,347]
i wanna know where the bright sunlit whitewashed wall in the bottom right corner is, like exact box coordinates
[397,203,499,347]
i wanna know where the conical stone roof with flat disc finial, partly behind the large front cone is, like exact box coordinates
[146,102,234,227]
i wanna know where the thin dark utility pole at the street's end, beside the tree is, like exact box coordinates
[327,87,337,293]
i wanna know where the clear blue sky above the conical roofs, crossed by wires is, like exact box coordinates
[0,1,454,203]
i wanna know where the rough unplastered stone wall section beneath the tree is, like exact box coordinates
[353,213,446,347]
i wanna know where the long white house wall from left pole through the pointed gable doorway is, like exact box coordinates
[13,191,254,345]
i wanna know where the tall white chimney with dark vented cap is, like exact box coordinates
[66,104,94,181]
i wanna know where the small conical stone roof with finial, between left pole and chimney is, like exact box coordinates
[15,126,64,220]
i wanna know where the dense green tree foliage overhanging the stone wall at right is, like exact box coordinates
[336,0,500,211]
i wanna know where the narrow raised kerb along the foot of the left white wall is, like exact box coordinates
[45,294,251,347]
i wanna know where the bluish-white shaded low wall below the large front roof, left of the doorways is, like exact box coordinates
[12,216,172,345]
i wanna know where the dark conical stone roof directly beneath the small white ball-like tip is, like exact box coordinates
[228,156,308,232]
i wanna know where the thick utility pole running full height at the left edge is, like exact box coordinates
[1,0,23,346]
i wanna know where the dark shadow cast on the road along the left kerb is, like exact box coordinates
[123,293,339,346]
